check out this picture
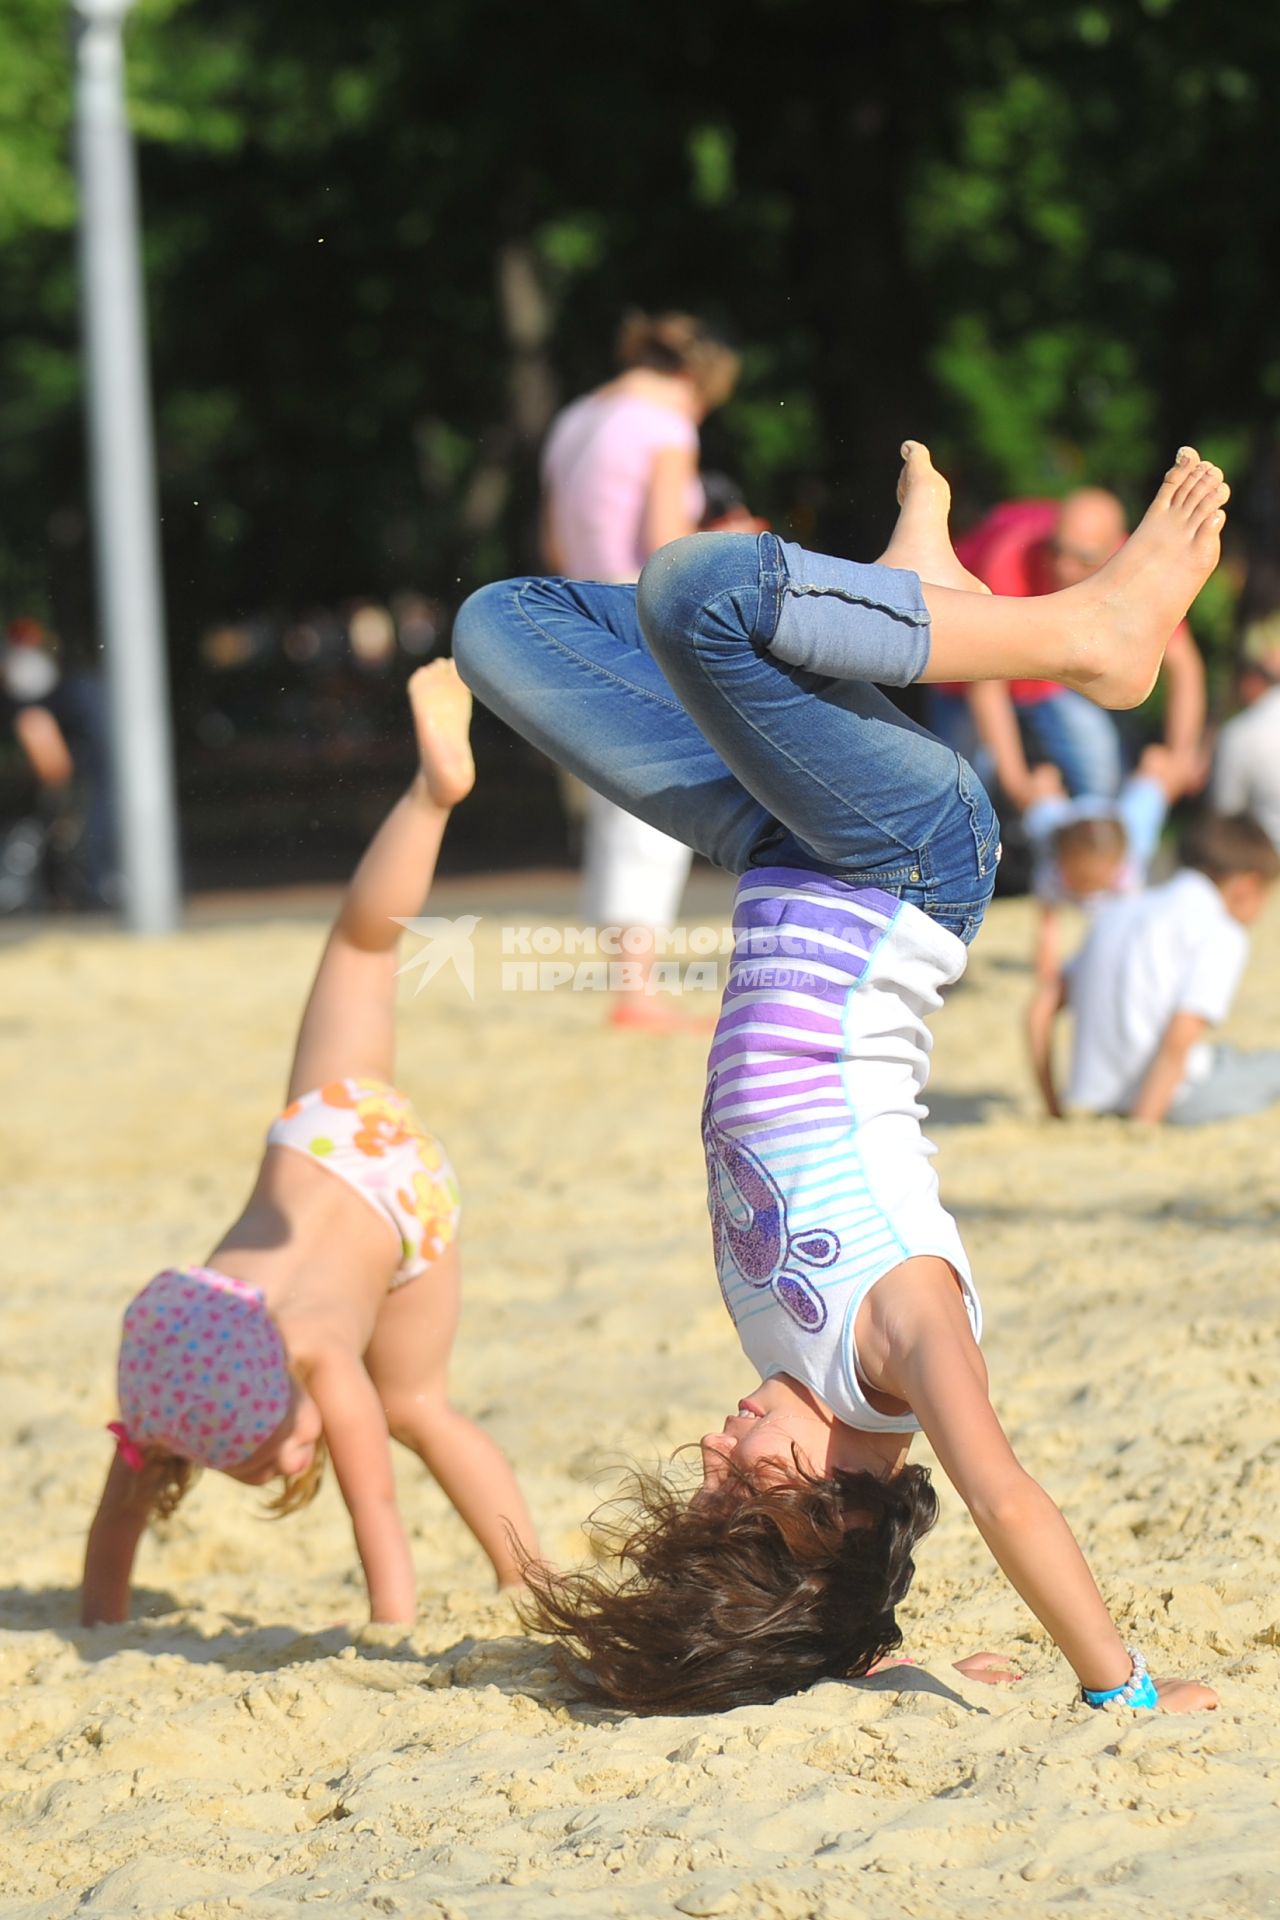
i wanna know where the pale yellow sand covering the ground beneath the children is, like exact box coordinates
[0,887,1280,1920]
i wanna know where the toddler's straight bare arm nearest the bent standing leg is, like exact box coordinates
[305,1350,416,1622]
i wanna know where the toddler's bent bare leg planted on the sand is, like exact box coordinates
[365,1246,537,1586]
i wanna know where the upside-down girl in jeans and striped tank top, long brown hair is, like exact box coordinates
[455,442,1228,1713]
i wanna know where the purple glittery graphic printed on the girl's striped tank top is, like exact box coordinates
[702,1079,841,1332]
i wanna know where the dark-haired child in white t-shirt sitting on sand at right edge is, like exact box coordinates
[1032,814,1280,1125]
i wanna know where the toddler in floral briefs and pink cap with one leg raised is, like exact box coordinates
[81,660,535,1626]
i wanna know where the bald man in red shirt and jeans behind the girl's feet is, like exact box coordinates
[929,488,1205,808]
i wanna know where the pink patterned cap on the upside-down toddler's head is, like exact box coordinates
[111,1267,294,1469]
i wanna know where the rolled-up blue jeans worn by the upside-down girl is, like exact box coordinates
[453,534,1000,941]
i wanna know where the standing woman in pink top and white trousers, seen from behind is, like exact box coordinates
[543,313,739,1025]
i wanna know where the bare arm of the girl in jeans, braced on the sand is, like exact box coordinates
[881,1261,1217,1709]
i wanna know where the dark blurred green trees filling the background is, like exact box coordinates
[0,0,1280,683]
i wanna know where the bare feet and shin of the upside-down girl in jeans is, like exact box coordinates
[881,440,1230,707]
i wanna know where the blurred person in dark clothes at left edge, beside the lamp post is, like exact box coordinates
[0,616,119,906]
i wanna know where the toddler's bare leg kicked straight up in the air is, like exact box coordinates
[288,660,476,1100]
